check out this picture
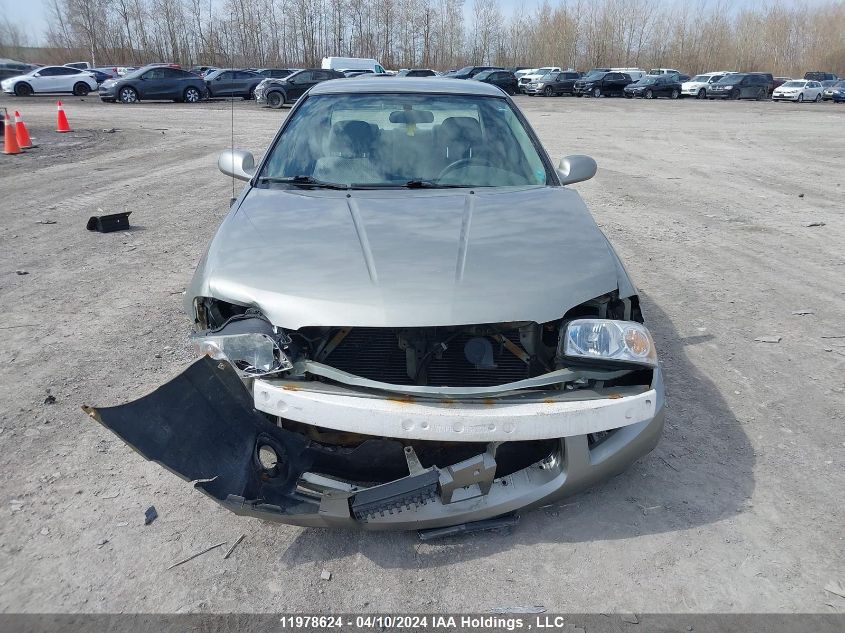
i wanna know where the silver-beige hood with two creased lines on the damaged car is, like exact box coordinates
[190,187,630,329]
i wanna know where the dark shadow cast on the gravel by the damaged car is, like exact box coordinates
[282,296,754,568]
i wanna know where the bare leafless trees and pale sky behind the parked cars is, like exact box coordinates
[0,0,845,75]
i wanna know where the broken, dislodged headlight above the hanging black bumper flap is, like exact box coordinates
[191,332,293,378]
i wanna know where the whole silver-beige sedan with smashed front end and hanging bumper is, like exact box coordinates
[87,79,664,530]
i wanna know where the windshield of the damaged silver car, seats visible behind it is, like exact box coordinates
[258,93,551,188]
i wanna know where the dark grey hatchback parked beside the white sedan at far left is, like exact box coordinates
[99,66,208,103]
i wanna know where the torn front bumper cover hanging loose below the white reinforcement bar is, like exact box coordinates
[84,357,664,530]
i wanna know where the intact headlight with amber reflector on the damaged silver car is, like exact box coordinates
[563,319,657,366]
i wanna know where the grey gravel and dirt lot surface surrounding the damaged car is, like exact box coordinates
[0,97,845,613]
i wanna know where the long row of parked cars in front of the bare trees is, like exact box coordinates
[0,57,845,108]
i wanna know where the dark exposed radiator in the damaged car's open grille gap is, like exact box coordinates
[323,328,529,387]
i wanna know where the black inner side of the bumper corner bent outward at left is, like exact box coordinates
[83,356,315,514]
